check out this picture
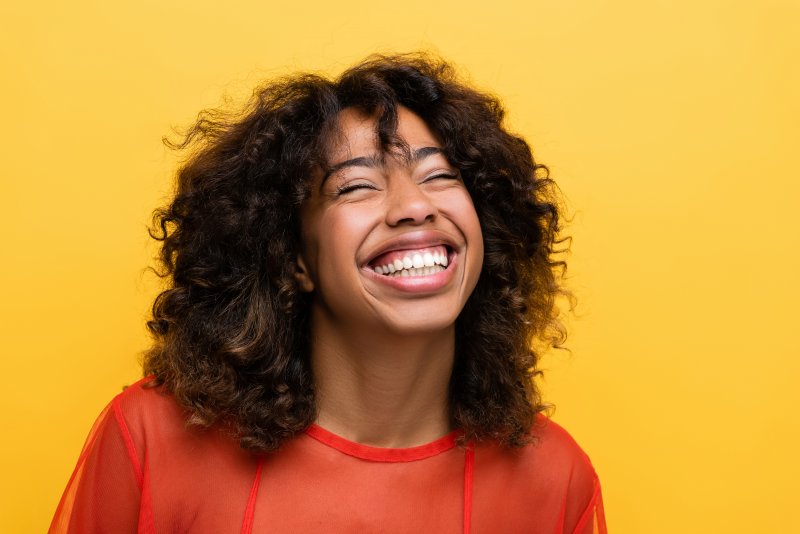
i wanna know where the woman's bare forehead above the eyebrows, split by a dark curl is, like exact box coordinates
[326,106,441,165]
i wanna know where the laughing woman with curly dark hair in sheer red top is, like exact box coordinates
[51,55,605,533]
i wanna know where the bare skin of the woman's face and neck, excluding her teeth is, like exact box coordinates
[297,107,483,447]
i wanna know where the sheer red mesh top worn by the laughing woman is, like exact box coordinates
[50,379,606,534]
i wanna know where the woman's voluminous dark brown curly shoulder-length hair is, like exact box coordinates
[143,54,570,451]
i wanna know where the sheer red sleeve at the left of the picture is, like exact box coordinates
[49,398,142,534]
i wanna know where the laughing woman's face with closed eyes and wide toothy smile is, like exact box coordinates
[298,107,483,334]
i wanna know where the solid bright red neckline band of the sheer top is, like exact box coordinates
[306,423,461,462]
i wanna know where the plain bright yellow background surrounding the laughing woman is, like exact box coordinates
[0,0,800,534]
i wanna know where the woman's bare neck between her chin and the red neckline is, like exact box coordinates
[311,308,455,447]
